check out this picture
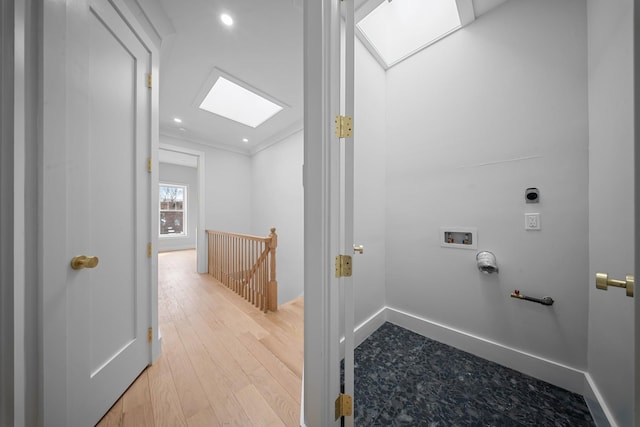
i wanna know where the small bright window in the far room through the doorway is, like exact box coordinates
[160,184,187,237]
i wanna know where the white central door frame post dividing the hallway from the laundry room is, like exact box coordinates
[301,0,340,427]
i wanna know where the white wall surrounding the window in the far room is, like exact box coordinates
[158,163,199,252]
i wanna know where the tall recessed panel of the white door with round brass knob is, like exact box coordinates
[87,8,138,371]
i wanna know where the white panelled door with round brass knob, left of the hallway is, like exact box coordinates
[42,0,151,426]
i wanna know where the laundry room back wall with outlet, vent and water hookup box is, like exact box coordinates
[386,0,588,369]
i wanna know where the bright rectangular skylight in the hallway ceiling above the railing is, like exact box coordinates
[200,76,282,128]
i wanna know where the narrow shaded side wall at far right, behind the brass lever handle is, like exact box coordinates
[586,0,640,426]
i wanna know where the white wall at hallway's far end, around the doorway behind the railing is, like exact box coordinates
[160,135,251,233]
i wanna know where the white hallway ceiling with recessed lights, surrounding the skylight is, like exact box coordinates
[152,0,506,153]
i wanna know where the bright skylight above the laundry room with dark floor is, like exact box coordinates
[356,0,462,68]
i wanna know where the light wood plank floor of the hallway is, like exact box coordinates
[98,251,304,427]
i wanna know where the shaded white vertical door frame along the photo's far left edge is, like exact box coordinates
[5,0,42,425]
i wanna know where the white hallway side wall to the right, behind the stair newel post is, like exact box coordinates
[251,132,304,304]
